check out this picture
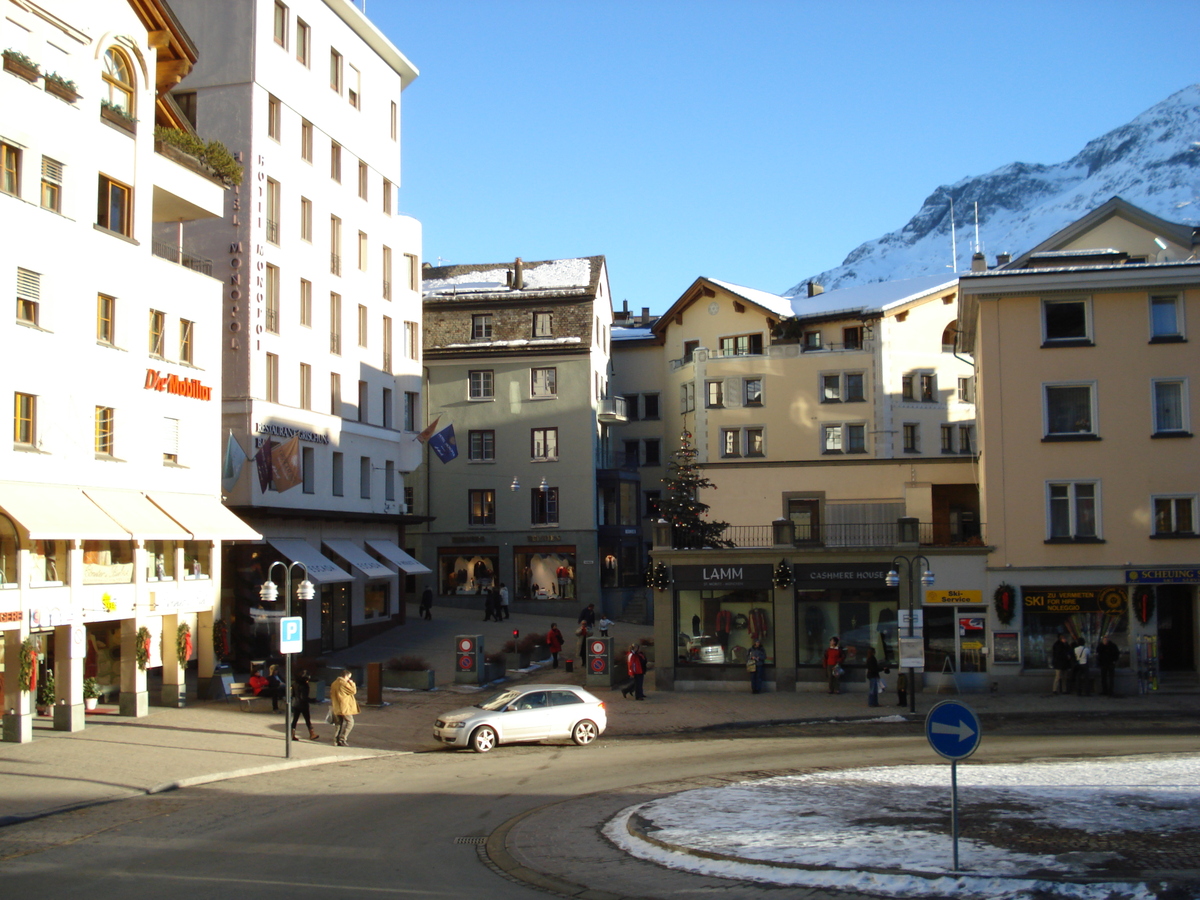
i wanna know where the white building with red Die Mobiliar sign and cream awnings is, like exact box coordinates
[0,0,258,742]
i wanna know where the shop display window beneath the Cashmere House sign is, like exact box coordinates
[796,590,900,666]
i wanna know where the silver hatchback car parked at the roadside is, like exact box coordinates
[433,684,608,754]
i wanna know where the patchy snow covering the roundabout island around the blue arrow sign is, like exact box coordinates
[605,756,1200,900]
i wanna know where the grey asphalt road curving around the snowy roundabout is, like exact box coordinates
[0,734,1200,900]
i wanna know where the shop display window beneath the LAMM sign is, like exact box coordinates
[676,589,775,666]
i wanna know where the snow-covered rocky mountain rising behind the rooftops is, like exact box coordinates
[785,84,1200,295]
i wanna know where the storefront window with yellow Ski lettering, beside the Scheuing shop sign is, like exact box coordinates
[1021,587,1129,668]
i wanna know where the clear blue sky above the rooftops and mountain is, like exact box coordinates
[367,0,1200,312]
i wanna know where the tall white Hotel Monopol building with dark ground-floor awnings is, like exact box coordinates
[173,0,426,658]
